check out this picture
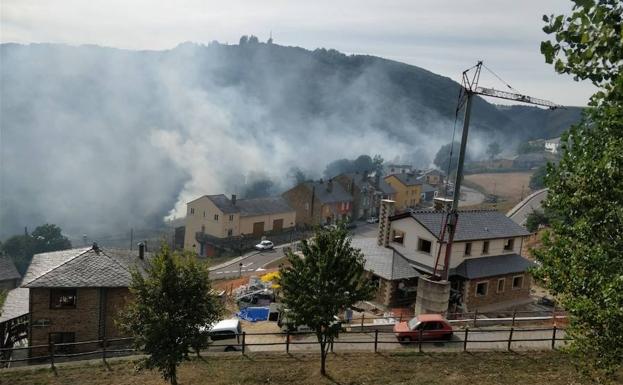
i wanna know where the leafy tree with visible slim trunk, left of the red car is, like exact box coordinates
[279,226,375,375]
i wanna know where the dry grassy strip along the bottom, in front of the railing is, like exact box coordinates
[0,352,616,385]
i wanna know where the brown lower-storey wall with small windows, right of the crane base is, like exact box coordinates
[463,273,532,311]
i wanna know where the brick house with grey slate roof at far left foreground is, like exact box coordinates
[22,244,151,357]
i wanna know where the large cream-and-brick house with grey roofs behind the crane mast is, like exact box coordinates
[353,201,533,311]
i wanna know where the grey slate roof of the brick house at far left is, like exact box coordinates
[22,248,151,288]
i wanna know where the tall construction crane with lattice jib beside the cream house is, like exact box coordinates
[433,61,562,281]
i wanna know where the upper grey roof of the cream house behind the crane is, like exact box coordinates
[400,210,530,241]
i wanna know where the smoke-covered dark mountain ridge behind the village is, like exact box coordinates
[0,42,581,237]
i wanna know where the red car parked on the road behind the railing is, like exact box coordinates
[394,314,452,342]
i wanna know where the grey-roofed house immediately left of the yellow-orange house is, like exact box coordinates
[333,172,396,219]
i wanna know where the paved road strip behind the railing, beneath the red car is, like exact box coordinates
[245,328,564,352]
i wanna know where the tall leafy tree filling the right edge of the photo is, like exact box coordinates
[535,0,623,374]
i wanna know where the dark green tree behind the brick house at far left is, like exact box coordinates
[2,224,71,275]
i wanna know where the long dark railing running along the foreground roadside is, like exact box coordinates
[0,325,570,368]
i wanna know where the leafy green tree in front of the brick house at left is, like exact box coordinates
[119,245,222,385]
